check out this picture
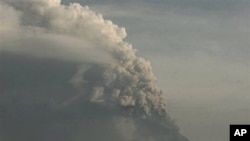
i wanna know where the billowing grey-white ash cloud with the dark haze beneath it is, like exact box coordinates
[0,0,188,141]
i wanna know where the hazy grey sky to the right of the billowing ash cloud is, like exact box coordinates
[60,0,250,141]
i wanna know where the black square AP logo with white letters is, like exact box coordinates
[230,125,250,141]
